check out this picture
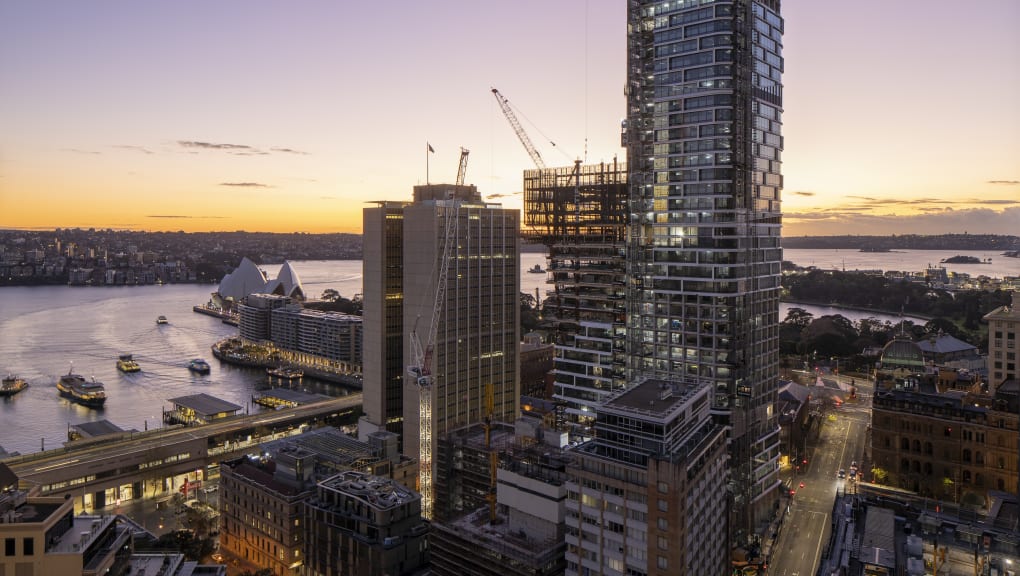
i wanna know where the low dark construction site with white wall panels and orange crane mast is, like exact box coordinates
[429,418,571,576]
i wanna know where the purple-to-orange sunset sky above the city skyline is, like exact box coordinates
[0,0,1020,237]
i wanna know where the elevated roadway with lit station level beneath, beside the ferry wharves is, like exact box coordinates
[3,394,361,511]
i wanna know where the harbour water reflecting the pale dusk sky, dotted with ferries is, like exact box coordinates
[0,250,1020,453]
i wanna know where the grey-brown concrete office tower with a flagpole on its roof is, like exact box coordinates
[359,185,520,517]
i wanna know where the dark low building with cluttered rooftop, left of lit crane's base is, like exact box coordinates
[303,471,428,576]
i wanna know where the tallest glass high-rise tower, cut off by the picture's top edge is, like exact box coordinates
[623,0,783,544]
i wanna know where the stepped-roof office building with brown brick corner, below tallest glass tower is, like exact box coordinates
[566,378,730,576]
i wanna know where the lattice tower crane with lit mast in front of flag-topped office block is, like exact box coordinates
[407,195,459,519]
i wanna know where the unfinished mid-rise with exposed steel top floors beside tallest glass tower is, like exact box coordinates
[524,159,627,422]
